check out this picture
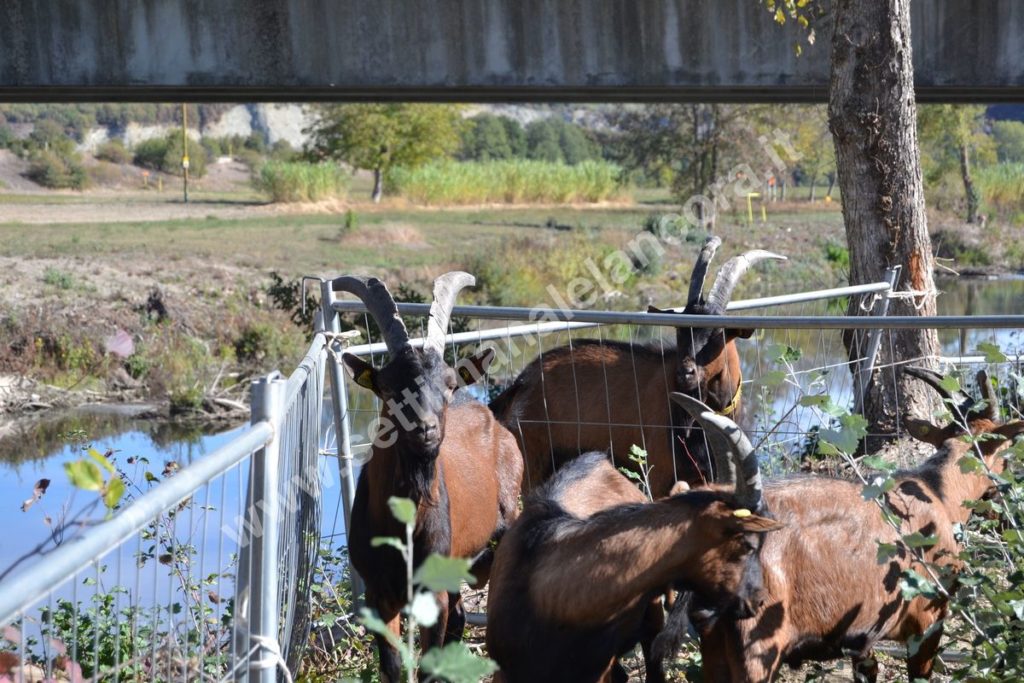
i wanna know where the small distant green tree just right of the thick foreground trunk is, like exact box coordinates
[918,104,995,223]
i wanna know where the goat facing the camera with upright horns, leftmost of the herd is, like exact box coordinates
[333,272,523,683]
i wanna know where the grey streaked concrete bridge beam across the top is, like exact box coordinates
[0,0,1024,101]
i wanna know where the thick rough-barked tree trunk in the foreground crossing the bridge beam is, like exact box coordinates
[828,0,939,451]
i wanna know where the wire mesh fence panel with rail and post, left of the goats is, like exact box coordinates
[0,335,326,681]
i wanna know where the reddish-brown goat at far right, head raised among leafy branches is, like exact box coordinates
[671,368,1024,683]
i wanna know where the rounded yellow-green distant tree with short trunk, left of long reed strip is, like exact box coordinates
[307,103,462,202]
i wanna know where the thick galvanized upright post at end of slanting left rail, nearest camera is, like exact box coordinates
[244,373,287,683]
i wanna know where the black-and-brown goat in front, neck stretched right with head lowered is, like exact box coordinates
[487,423,778,683]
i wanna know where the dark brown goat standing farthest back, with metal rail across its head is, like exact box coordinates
[490,237,784,498]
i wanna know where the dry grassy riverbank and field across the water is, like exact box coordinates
[0,189,1013,432]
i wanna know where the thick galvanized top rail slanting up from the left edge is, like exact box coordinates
[0,422,273,625]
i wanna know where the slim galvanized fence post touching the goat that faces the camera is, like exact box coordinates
[321,280,365,604]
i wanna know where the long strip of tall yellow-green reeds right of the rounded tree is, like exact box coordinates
[388,161,623,205]
